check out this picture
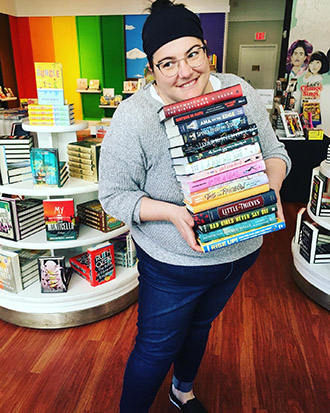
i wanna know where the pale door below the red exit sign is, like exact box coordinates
[238,44,277,89]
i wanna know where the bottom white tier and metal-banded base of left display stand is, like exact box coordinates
[0,265,138,329]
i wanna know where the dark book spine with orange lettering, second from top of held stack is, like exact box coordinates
[165,96,247,125]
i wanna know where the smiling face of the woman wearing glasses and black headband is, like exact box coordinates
[153,36,213,104]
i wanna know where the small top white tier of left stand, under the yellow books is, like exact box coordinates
[22,120,88,161]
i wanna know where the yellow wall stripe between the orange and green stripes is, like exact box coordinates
[52,16,83,120]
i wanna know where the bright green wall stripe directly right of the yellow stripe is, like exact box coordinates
[76,16,104,120]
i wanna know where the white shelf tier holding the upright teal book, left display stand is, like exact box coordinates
[0,177,98,197]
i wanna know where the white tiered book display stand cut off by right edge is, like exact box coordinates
[291,156,330,310]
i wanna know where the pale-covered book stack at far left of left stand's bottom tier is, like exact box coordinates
[0,248,50,293]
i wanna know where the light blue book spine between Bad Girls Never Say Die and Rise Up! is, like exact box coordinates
[198,214,276,242]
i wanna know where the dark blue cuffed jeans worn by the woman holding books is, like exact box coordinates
[120,246,259,413]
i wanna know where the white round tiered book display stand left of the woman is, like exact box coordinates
[0,121,138,329]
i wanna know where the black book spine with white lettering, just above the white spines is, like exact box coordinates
[182,125,258,155]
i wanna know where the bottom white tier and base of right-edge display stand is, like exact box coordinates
[291,240,330,310]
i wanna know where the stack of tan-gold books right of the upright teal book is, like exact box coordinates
[67,138,102,182]
